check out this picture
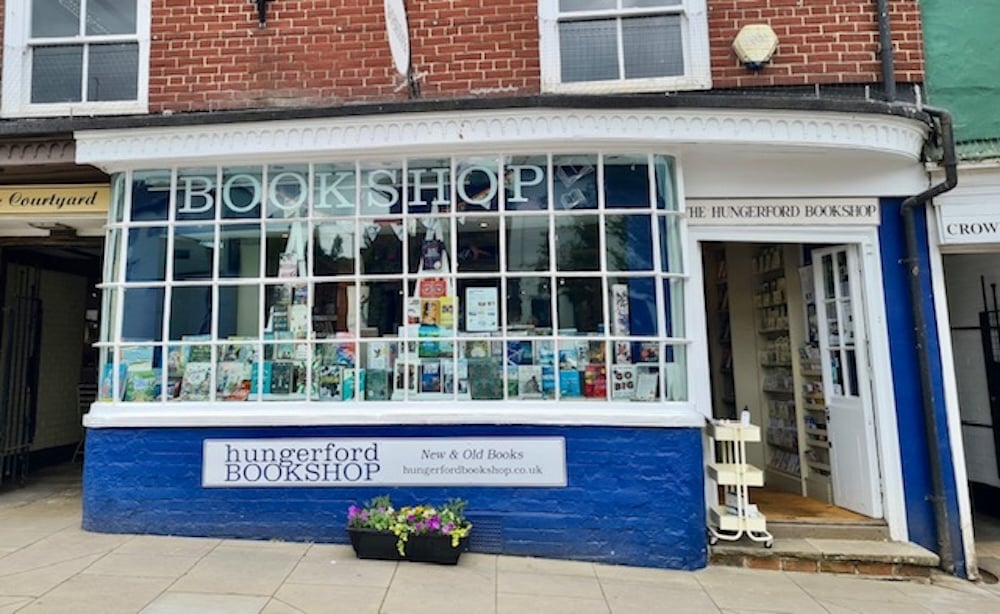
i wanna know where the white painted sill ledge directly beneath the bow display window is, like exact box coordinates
[84,401,705,429]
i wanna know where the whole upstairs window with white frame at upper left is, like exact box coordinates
[3,0,149,116]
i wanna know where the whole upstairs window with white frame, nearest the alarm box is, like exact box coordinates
[539,0,711,94]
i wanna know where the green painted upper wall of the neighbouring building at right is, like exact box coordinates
[921,0,1000,150]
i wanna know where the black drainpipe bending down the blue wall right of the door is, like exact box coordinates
[900,107,958,574]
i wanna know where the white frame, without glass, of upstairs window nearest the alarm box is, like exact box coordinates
[538,0,712,94]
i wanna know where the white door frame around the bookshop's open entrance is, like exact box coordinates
[684,226,909,541]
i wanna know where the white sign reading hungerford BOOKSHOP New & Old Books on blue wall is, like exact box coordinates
[201,437,566,488]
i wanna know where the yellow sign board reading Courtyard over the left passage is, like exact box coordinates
[0,183,111,216]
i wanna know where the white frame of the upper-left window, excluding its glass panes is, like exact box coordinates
[0,0,150,117]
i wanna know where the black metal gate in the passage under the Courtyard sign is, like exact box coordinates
[0,265,42,484]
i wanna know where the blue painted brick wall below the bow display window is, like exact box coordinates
[83,426,707,569]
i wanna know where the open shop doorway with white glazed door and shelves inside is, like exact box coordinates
[701,242,884,524]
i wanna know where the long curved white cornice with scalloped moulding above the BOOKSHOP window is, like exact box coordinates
[75,108,927,171]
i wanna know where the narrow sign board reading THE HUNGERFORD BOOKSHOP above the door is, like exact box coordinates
[686,198,879,226]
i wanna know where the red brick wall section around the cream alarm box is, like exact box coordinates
[708,0,923,88]
